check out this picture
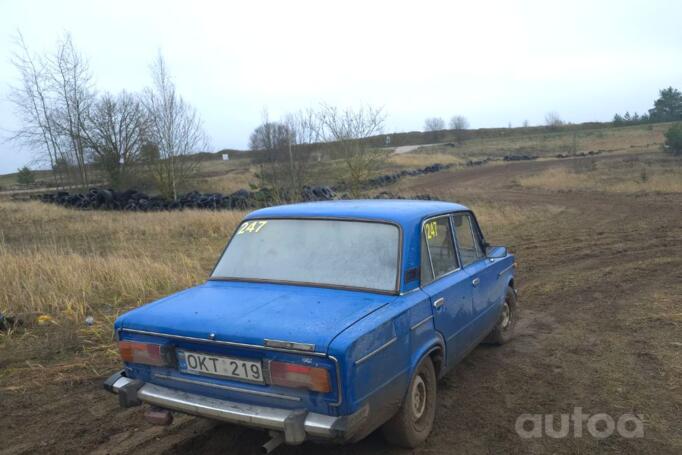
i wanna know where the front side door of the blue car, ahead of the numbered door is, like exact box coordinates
[452,212,499,331]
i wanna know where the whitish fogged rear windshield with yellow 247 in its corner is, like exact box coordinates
[211,219,400,291]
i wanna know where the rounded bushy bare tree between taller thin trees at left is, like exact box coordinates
[84,91,148,188]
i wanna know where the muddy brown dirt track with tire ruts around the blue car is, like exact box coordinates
[0,155,682,455]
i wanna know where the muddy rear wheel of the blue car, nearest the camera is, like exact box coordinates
[381,357,437,449]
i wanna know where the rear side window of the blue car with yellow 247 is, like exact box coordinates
[422,216,458,285]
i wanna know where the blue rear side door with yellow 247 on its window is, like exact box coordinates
[420,215,473,363]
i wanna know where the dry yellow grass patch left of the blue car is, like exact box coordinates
[0,202,243,350]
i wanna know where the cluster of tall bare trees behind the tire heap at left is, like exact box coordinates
[10,33,209,199]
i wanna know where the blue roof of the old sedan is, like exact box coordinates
[247,199,469,229]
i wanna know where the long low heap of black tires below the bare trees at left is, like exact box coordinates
[37,186,336,212]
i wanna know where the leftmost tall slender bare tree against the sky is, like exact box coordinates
[9,33,65,186]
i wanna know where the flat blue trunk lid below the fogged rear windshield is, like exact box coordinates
[116,281,395,352]
